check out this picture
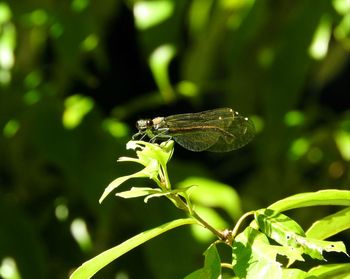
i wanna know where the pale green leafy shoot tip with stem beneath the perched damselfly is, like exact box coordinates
[100,140,226,241]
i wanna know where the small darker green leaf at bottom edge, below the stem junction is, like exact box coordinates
[185,244,221,279]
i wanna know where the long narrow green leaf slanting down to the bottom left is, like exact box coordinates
[70,218,197,279]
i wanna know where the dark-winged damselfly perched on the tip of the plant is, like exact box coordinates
[133,108,255,152]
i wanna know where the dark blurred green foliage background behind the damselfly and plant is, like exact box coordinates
[0,0,350,279]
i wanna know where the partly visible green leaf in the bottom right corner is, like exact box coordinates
[307,263,350,279]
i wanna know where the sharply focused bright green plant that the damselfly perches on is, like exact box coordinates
[70,141,350,279]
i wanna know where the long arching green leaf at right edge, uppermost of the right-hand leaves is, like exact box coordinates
[268,189,350,212]
